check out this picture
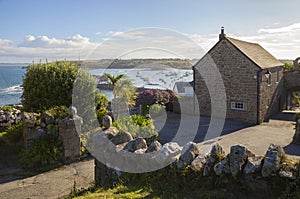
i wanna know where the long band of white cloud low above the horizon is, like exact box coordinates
[0,23,300,62]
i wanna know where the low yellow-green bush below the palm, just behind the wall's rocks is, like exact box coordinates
[113,115,158,138]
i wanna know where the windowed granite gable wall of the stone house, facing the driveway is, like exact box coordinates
[194,40,259,124]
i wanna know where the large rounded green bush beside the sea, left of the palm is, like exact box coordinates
[22,61,95,112]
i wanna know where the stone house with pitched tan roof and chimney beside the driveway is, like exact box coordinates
[193,27,284,124]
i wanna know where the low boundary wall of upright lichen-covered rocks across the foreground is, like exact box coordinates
[92,123,299,188]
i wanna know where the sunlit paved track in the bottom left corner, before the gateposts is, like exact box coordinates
[0,159,94,199]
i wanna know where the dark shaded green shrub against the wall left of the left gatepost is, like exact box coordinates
[20,125,64,169]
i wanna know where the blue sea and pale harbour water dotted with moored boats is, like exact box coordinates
[0,65,193,106]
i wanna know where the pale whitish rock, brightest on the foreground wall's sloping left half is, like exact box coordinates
[156,142,182,163]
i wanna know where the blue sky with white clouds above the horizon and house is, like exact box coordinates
[0,0,300,62]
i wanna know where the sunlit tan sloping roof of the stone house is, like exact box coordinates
[225,37,283,69]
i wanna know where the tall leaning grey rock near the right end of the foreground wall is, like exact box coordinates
[261,144,284,177]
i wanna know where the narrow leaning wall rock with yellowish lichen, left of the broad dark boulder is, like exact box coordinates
[203,143,225,176]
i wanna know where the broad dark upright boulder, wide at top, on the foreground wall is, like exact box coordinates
[229,145,254,178]
